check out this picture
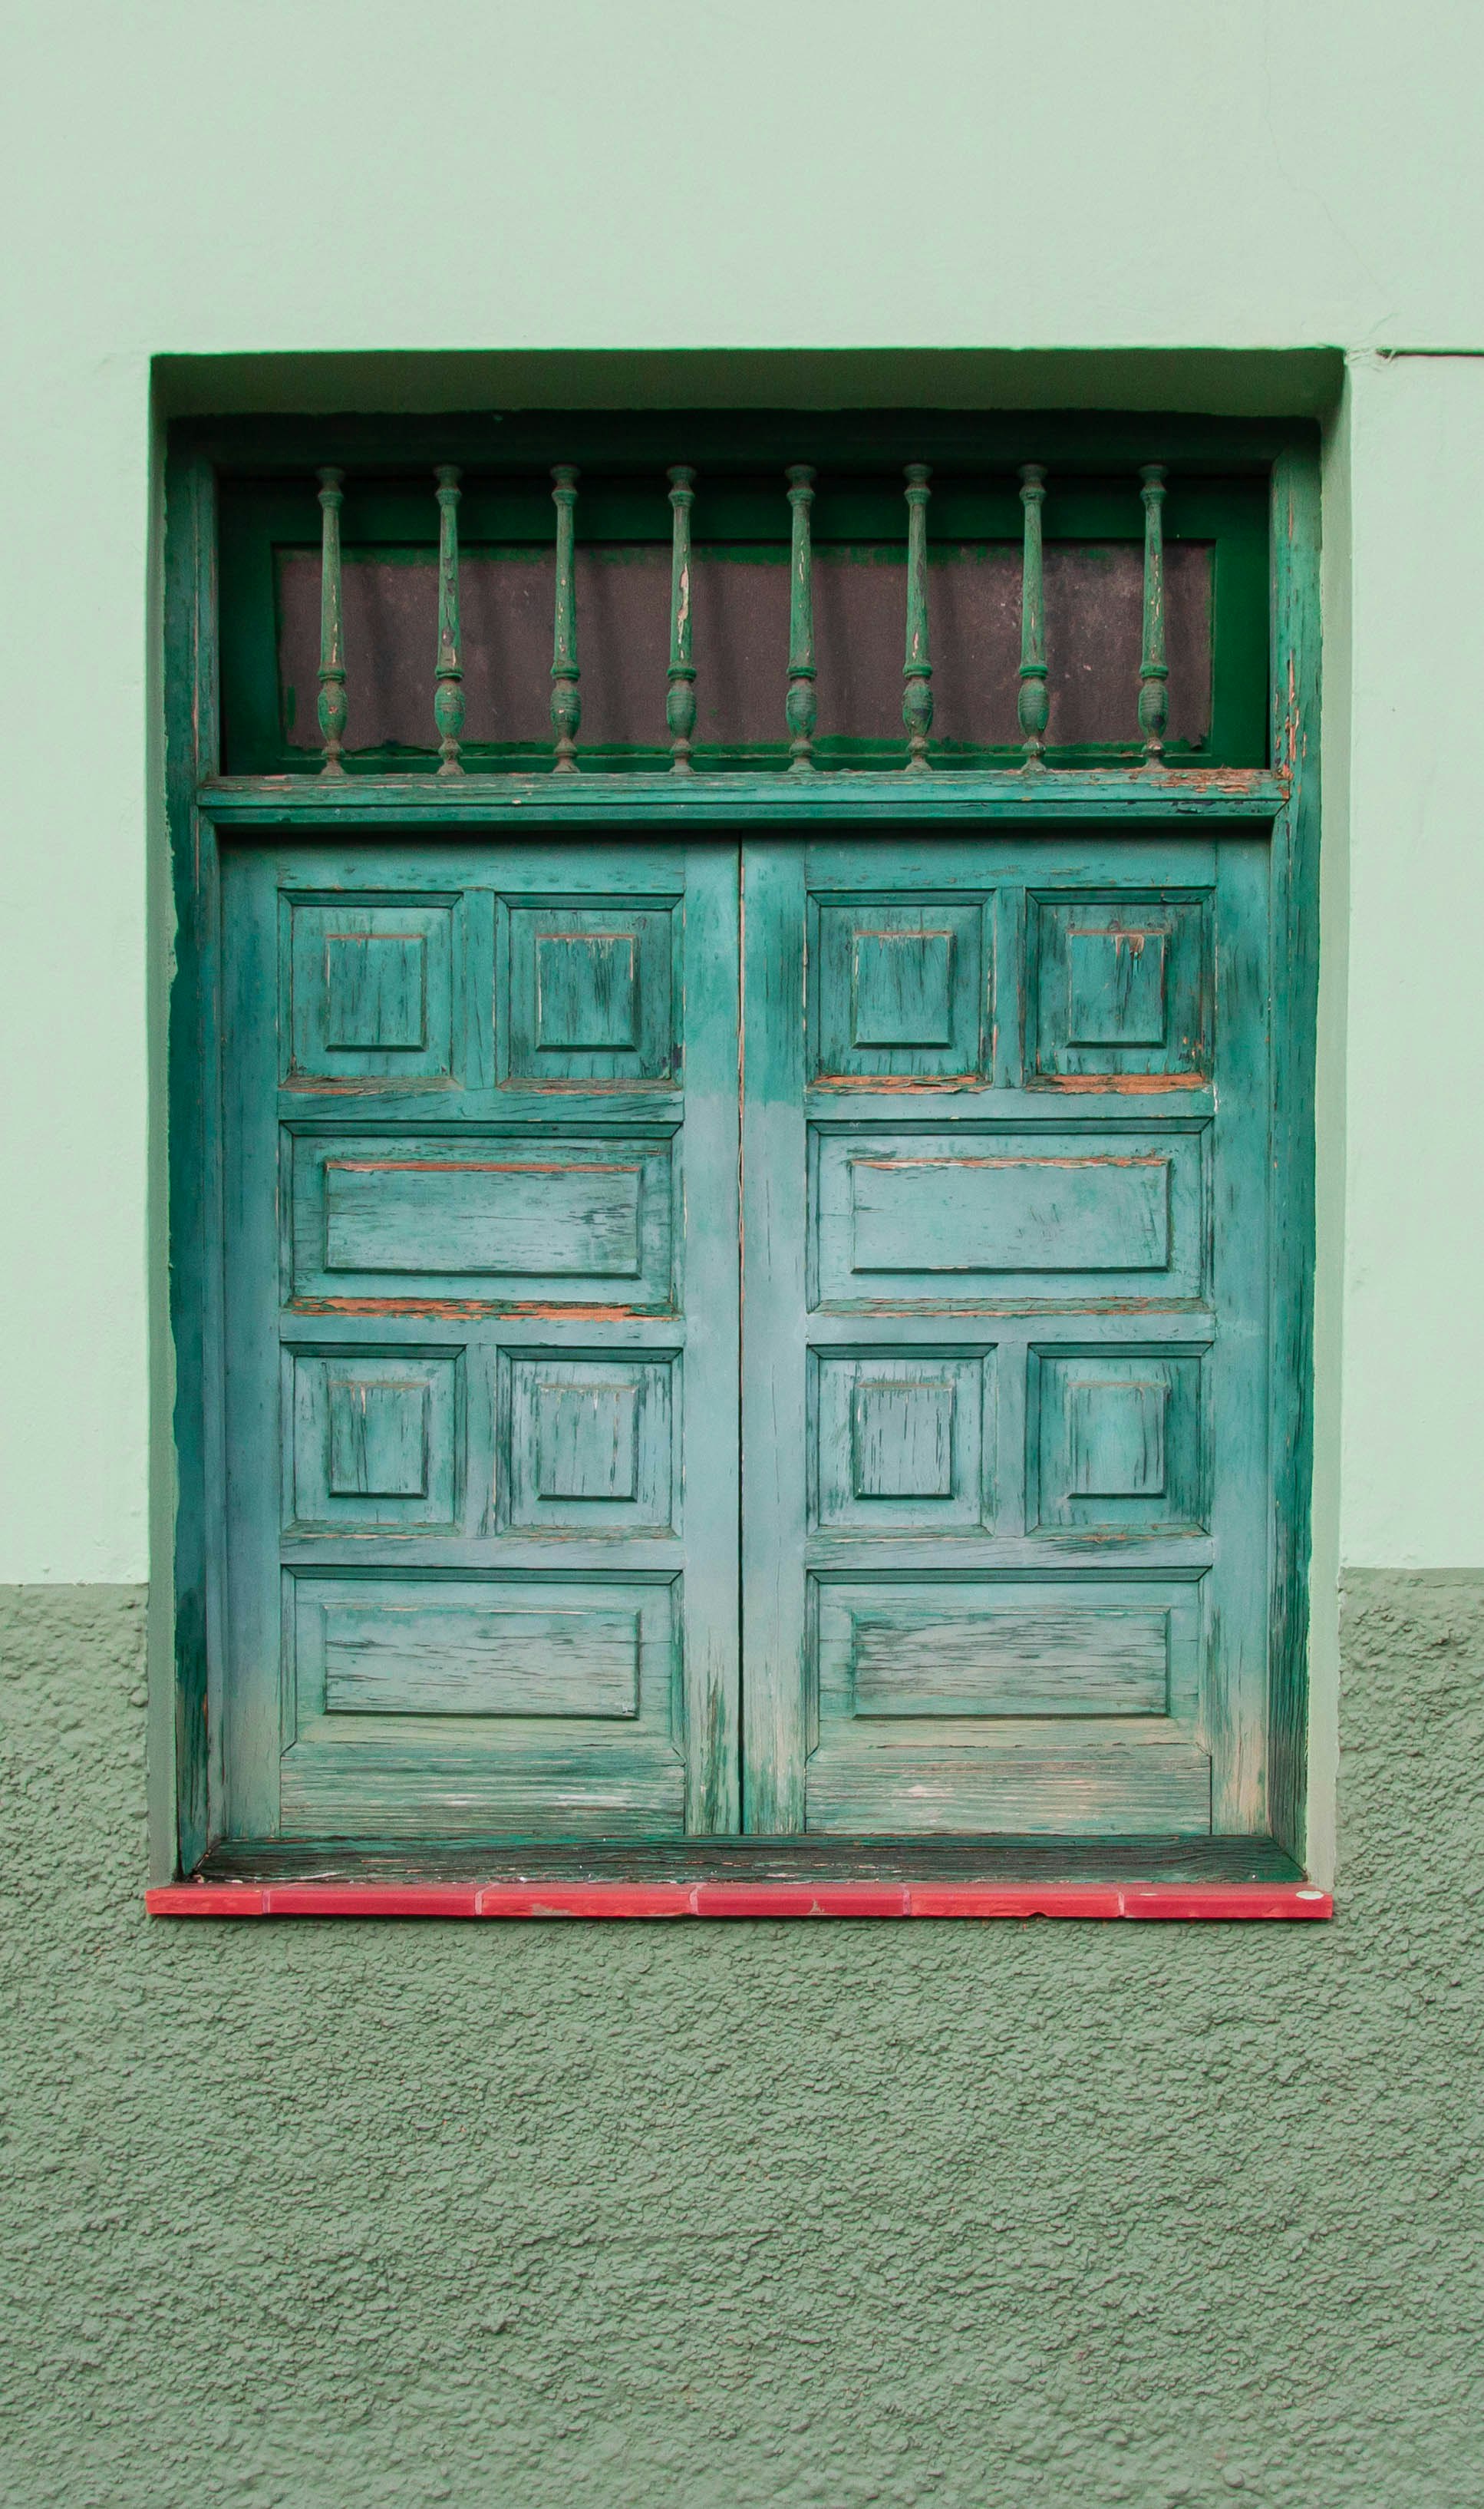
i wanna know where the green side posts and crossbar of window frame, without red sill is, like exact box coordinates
[153,417,1321,1882]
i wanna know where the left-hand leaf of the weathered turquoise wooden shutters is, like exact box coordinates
[223,843,740,1839]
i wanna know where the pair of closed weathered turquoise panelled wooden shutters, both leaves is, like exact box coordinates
[218,828,1271,1839]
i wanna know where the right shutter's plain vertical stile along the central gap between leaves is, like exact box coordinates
[742,843,810,1834]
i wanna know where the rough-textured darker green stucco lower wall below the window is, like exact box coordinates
[0,1573,1484,2509]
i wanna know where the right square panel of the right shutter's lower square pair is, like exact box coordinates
[1025,1345,1209,1533]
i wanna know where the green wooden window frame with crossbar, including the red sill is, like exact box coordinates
[150,411,1328,1917]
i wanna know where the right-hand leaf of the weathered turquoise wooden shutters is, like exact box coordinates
[742,836,1271,1834]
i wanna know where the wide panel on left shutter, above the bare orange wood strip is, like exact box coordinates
[293,1129,672,1309]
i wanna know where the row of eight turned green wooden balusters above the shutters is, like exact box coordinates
[318,461,1168,775]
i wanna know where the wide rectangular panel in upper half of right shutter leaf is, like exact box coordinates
[815,1127,1203,1307]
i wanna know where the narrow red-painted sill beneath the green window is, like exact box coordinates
[145,1882,1334,1922]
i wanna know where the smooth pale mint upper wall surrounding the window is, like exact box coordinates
[0,0,1484,1580]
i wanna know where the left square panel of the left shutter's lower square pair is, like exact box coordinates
[283,1350,463,1533]
